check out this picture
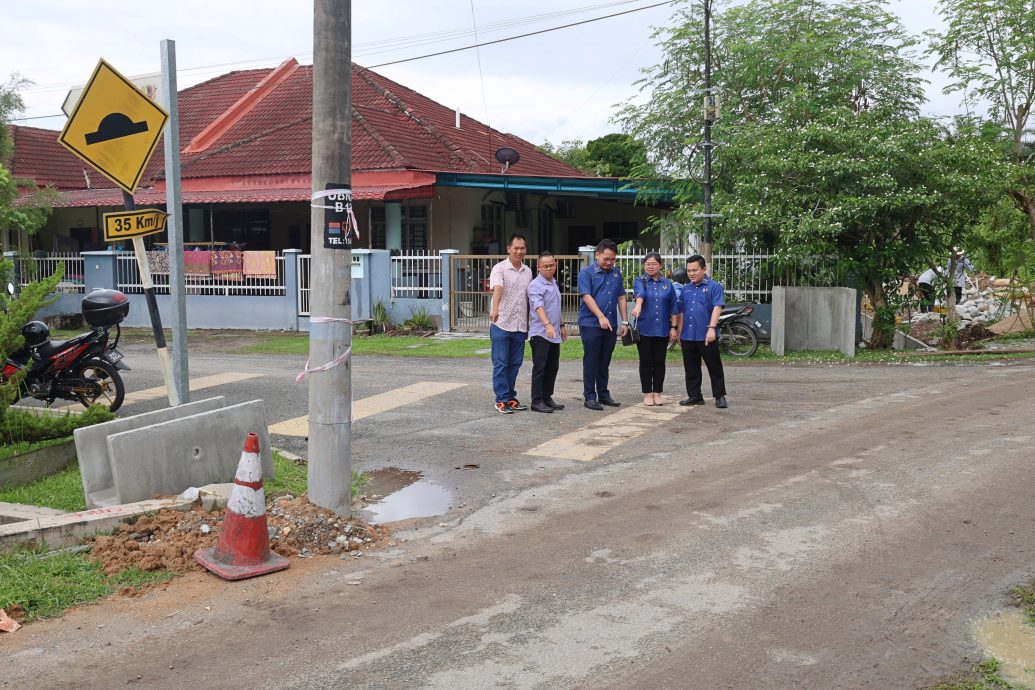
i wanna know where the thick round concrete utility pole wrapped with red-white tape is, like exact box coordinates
[308,0,352,516]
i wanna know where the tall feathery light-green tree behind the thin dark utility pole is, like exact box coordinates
[616,0,923,183]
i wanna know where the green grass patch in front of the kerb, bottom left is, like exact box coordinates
[0,550,173,620]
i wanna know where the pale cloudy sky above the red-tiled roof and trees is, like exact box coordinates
[0,0,962,144]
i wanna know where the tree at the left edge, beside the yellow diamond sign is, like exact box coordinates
[0,76,56,243]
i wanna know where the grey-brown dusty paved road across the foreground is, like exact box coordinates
[0,353,1035,689]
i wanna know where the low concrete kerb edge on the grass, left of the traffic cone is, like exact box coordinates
[0,498,194,551]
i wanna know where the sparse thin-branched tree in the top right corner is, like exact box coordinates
[928,0,1035,242]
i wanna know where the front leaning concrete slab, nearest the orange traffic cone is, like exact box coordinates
[108,400,273,503]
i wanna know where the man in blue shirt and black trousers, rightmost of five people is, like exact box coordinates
[676,254,727,409]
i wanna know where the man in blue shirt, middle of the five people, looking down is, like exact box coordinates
[579,240,628,410]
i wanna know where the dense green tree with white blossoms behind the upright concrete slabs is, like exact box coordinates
[716,107,1005,349]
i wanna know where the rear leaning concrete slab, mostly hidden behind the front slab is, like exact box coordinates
[75,396,227,508]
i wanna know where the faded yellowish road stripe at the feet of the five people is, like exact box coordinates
[525,404,689,462]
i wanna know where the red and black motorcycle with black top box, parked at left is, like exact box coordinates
[0,290,129,412]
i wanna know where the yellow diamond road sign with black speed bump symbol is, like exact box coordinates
[58,60,169,194]
